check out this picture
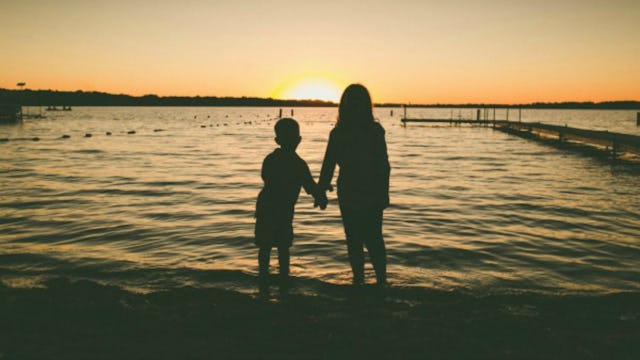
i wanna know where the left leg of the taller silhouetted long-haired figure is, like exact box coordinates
[340,206,364,285]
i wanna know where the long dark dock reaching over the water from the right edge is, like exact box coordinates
[400,118,640,158]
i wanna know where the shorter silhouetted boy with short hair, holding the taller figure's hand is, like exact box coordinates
[255,118,327,285]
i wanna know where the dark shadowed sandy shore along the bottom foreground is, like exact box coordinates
[0,280,640,360]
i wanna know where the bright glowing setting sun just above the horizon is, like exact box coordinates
[274,78,342,102]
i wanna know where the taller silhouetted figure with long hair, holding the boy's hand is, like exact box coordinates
[318,84,390,285]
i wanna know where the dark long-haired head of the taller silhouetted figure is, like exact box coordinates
[336,84,375,128]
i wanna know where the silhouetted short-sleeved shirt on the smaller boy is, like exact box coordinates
[256,148,315,226]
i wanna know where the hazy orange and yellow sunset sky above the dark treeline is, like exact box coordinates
[0,0,640,103]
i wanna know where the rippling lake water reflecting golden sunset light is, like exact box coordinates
[0,107,640,294]
